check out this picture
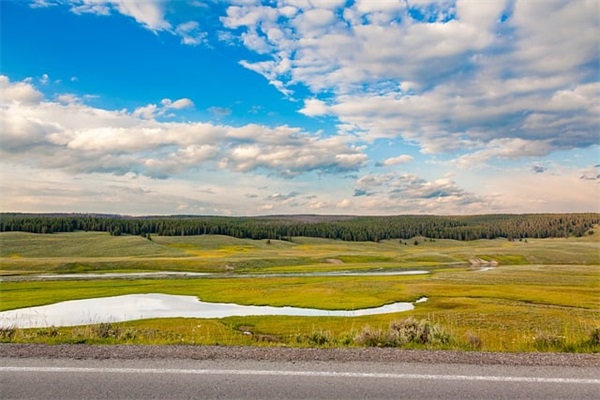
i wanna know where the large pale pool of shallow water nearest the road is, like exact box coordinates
[0,293,427,328]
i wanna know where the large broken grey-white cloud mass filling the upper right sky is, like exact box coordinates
[222,0,600,165]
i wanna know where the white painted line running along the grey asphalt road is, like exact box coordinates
[0,367,600,385]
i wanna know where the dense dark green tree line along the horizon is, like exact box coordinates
[0,213,600,242]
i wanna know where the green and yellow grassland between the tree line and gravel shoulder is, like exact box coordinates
[0,229,600,351]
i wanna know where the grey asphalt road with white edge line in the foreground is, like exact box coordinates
[0,357,600,400]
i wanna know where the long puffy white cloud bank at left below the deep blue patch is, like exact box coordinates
[0,76,367,178]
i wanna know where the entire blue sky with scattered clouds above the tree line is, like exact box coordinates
[0,0,600,216]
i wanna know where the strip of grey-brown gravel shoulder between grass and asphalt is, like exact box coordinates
[0,344,600,367]
